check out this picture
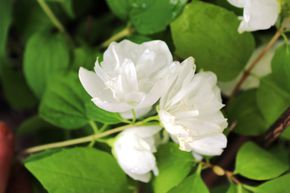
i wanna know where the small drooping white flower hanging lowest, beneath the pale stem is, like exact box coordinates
[113,126,161,182]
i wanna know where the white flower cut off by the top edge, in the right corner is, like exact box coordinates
[228,0,280,33]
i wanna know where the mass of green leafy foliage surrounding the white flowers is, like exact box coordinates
[0,0,290,193]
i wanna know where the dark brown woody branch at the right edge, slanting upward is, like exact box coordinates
[264,107,290,147]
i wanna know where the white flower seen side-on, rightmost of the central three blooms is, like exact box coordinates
[159,57,227,156]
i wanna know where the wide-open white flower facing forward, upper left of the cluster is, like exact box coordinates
[79,40,174,118]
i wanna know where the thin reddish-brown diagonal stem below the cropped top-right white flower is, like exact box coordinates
[230,29,282,98]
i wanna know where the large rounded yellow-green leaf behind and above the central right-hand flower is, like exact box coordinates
[171,1,255,81]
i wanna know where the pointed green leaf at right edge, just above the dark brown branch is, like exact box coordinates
[257,75,290,124]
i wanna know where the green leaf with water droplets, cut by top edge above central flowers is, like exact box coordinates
[107,0,187,34]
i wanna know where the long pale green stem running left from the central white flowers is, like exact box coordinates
[24,120,156,154]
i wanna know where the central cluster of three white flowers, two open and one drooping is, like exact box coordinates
[79,40,227,182]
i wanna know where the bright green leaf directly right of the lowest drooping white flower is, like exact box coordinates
[153,143,195,193]
